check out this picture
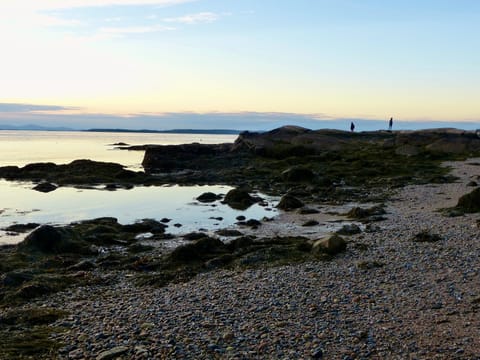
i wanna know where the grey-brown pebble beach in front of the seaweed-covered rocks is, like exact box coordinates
[16,159,480,360]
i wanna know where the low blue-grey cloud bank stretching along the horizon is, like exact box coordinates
[0,103,480,131]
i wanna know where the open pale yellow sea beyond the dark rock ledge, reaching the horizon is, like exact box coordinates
[0,130,237,170]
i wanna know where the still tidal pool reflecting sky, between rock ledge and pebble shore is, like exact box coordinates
[0,180,276,244]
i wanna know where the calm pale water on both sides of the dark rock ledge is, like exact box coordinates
[0,130,278,245]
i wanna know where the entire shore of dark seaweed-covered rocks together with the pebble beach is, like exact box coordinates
[0,126,480,359]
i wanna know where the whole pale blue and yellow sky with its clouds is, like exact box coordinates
[0,0,480,129]
